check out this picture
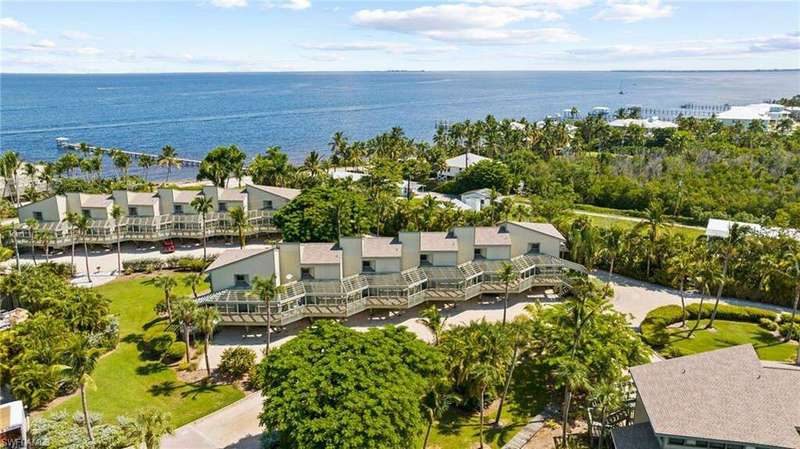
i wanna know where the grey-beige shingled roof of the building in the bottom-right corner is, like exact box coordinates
[630,345,800,449]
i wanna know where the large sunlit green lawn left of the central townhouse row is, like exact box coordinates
[53,276,244,426]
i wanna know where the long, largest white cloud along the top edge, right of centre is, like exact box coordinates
[353,4,561,33]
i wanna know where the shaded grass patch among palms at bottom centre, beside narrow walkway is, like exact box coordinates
[424,364,549,449]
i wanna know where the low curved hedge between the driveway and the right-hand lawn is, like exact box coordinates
[640,302,778,348]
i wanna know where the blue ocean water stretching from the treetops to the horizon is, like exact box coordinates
[0,71,800,161]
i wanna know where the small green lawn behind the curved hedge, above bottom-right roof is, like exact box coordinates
[668,320,797,362]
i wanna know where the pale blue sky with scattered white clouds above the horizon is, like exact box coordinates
[0,0,800,73]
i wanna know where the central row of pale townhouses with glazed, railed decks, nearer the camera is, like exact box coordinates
[198,221,585,326]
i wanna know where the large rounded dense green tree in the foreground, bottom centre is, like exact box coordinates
[259,321,444,449]
